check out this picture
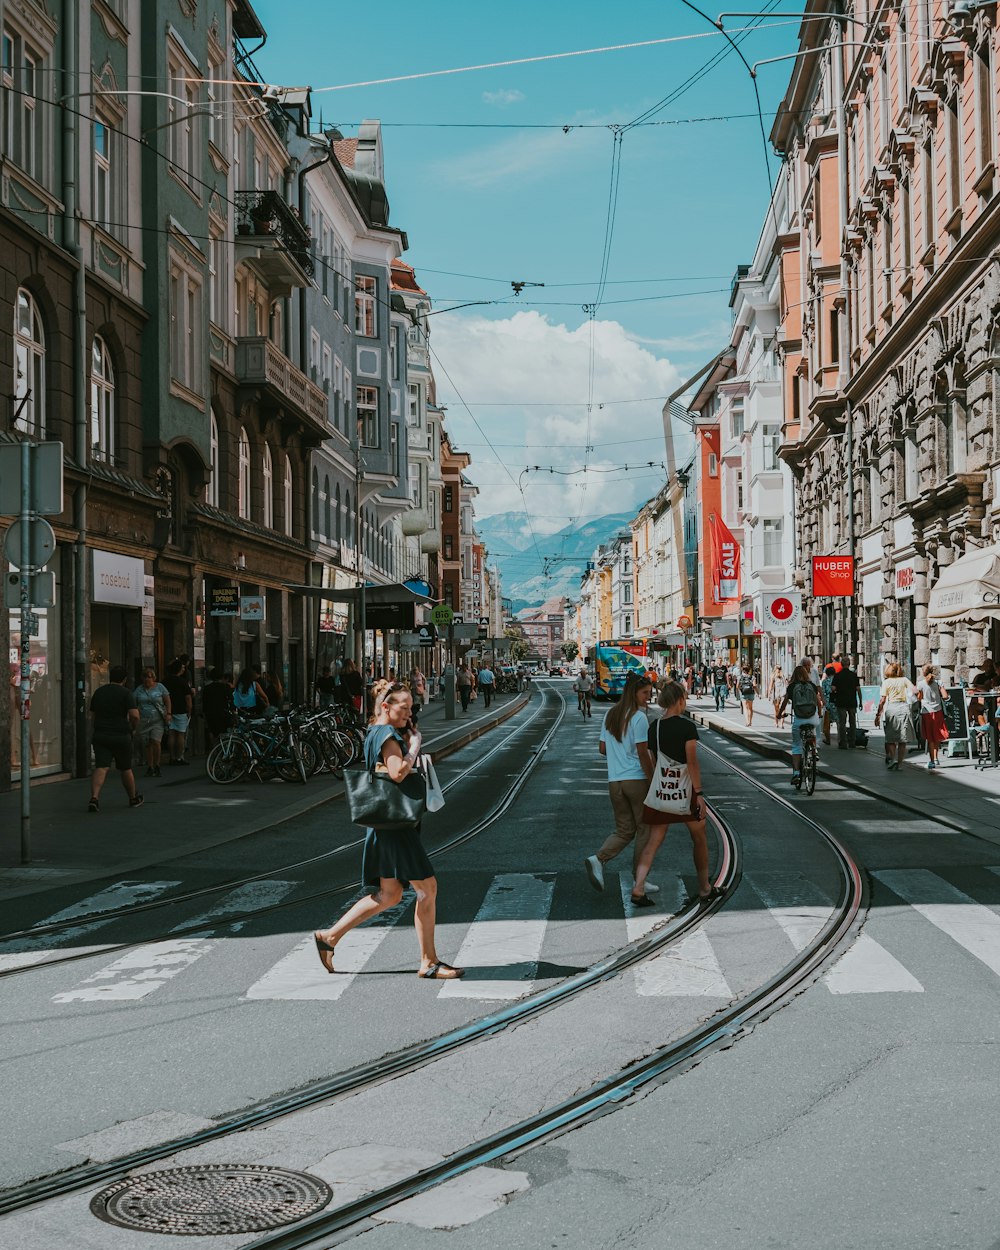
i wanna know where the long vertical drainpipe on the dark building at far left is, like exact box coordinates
[63,0,90,776]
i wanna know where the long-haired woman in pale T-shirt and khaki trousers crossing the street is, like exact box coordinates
[584,675,656,891]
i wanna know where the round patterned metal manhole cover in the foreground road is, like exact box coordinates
[90,1164,334,1236]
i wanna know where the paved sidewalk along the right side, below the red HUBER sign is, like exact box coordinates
[688,695,1000,845]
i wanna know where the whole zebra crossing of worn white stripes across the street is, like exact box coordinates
[15,865,1000,1008]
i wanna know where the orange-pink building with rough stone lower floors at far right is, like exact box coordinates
[771,0,1000,680]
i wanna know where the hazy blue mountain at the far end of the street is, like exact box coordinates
[476,513,635,613]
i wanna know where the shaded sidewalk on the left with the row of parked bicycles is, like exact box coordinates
[0,694,530,900]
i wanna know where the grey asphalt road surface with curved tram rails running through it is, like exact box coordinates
[0,681,1000,1250]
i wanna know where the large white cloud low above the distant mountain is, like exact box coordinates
[431,310,681,536]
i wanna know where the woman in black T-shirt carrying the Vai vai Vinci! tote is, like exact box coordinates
[631,681,723,908]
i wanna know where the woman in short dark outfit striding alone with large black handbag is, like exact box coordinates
[313,683,465,981]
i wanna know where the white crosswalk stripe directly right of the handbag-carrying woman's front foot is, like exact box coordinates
[438,873,555,999]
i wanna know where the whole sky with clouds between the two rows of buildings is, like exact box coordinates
[255,0,798,536]
